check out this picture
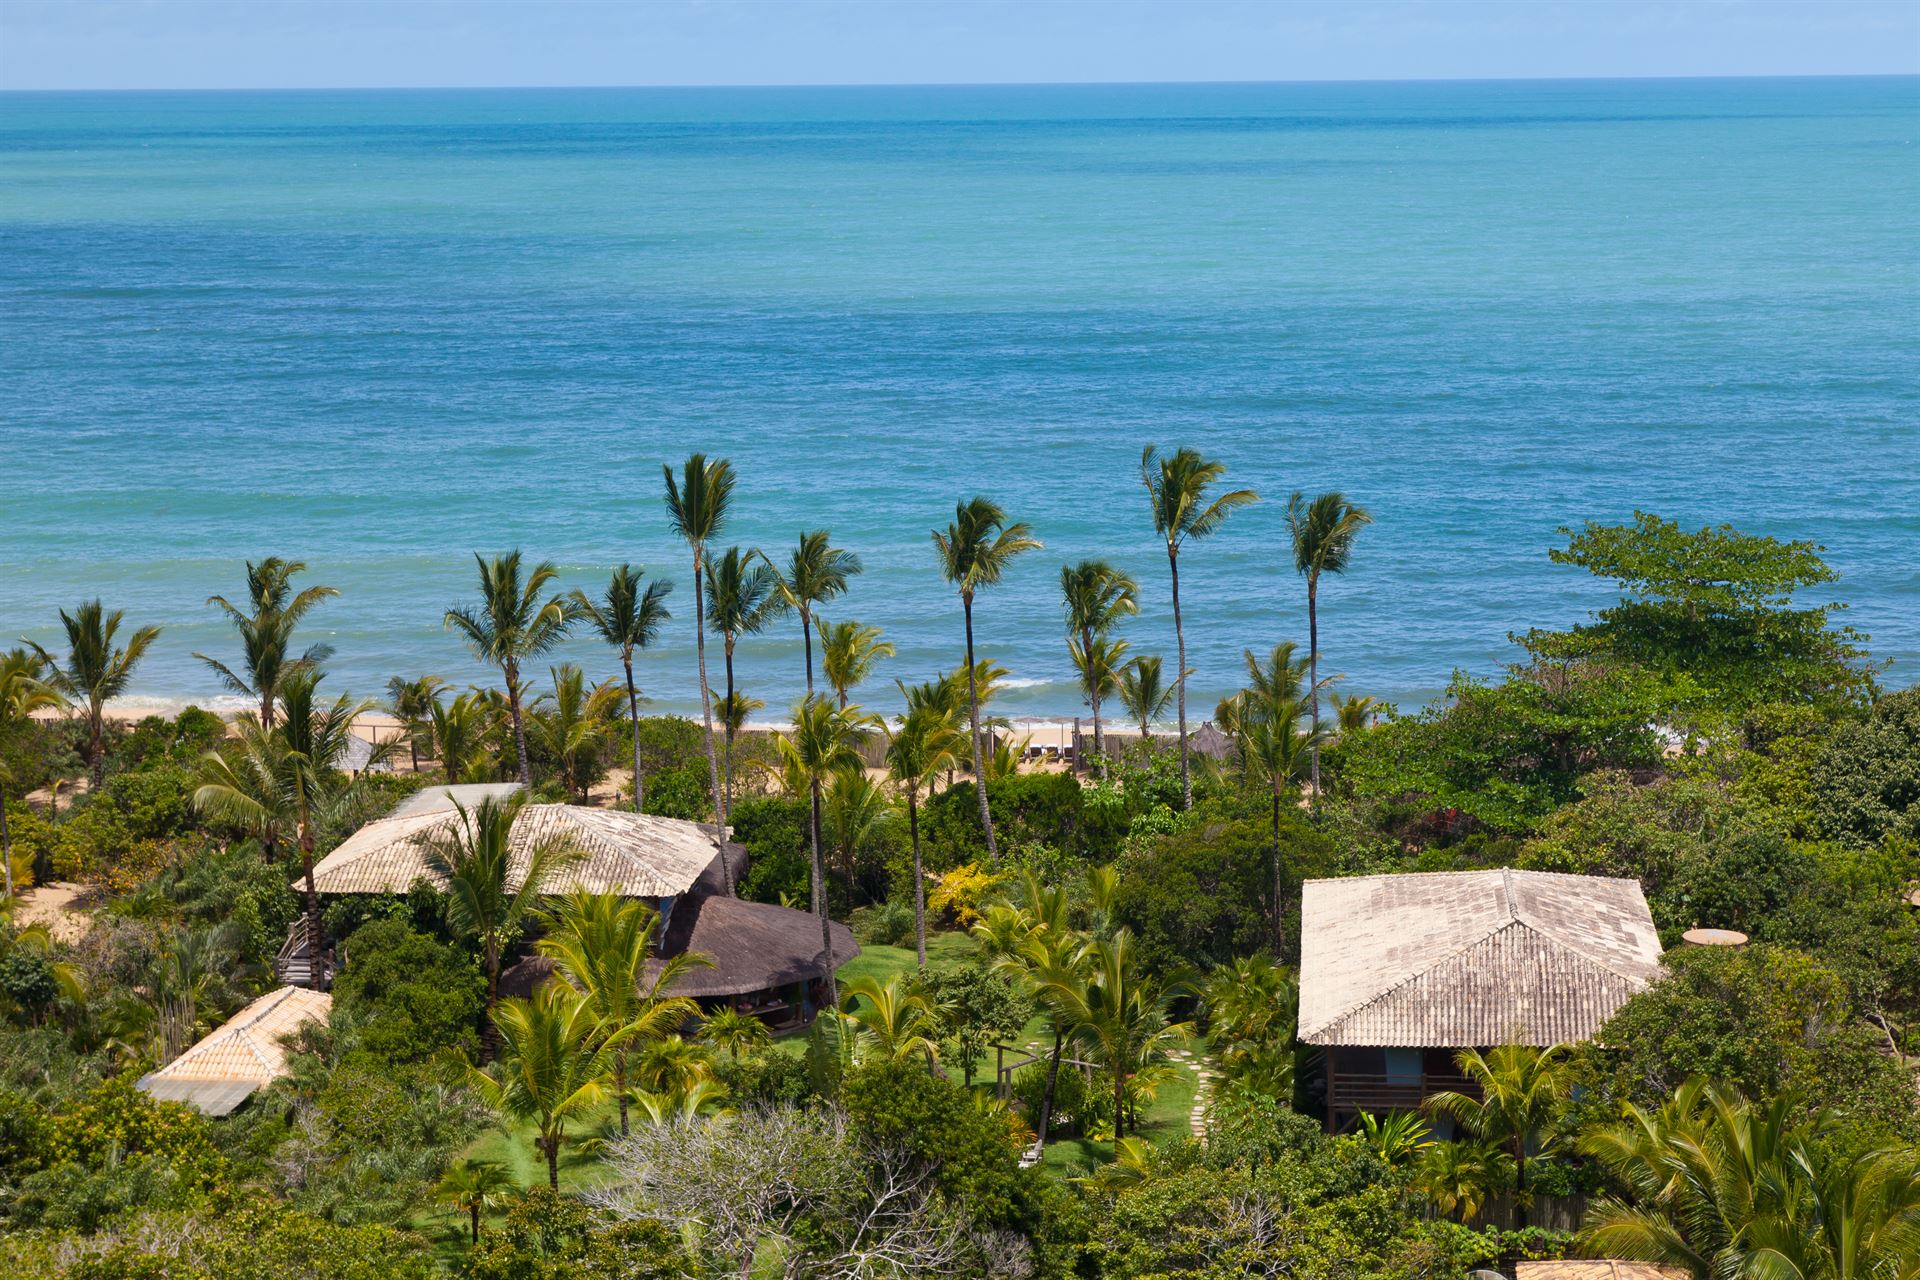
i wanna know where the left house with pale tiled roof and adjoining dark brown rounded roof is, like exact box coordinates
[305,783,860,1029]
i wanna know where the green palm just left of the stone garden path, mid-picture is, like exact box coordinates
[1039,929,1190,1138]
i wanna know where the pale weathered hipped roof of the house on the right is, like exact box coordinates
[1300,871,1661,1048]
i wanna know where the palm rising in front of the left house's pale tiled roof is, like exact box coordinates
[415,791,582,1036]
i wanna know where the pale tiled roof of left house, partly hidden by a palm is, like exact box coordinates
[307,804,714,898]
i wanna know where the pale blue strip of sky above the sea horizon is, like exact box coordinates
[0,0,1920,88]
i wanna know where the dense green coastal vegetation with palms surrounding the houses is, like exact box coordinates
[0,475,1920,1280]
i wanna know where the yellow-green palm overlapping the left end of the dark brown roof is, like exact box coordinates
[534,889,712,1138]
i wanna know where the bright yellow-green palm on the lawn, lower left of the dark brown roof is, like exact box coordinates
[467,983,624,1190]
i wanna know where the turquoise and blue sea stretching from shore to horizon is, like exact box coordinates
[0,79,1920,716]
